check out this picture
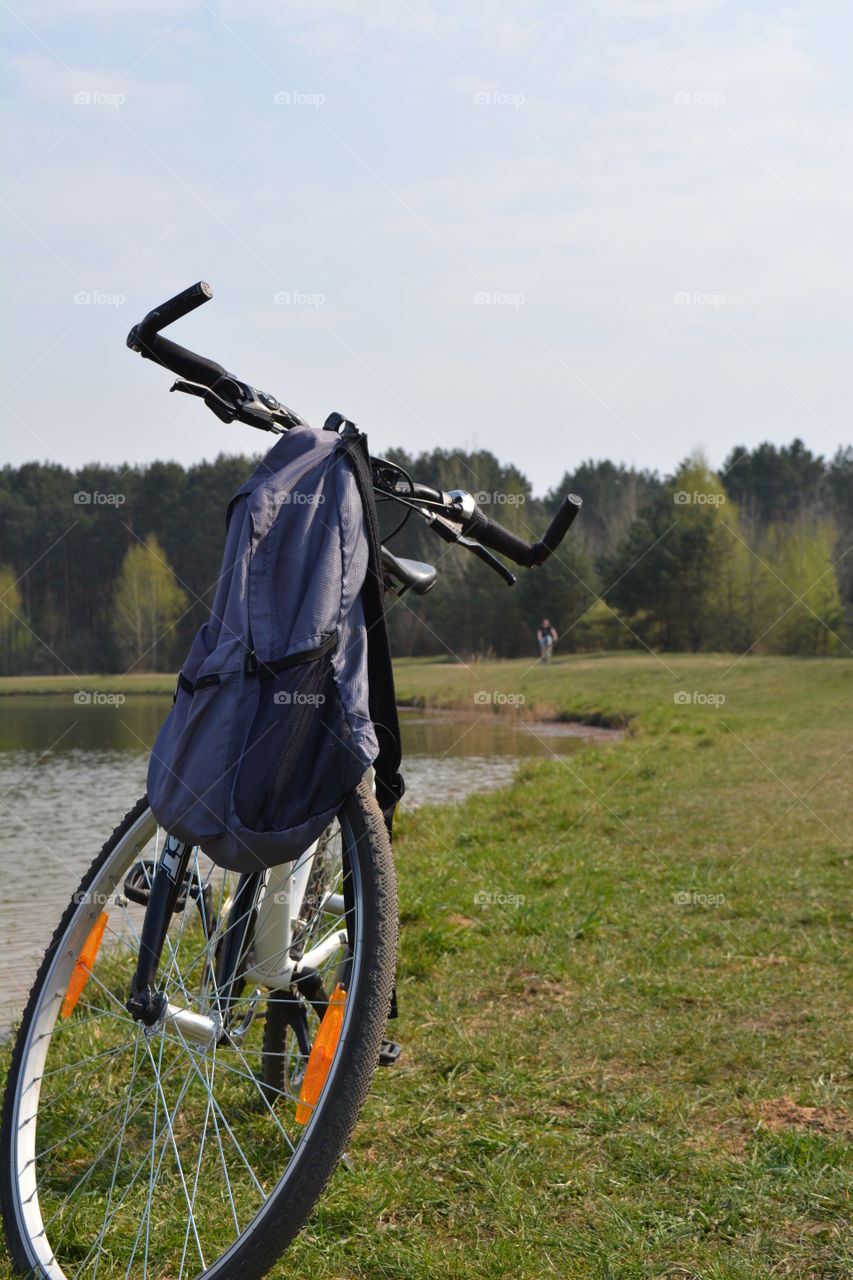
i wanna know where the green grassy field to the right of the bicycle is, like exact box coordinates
[1,655,853,1280]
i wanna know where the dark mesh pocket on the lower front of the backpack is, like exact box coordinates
[234,646,364,832]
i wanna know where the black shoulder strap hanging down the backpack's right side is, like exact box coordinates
[341,429,405,835]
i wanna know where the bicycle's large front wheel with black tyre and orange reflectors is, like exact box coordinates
[0,783,397,1280]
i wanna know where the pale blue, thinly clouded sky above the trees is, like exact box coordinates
[0,0,853,493]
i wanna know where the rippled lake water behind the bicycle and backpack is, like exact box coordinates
[0,694,603,1034]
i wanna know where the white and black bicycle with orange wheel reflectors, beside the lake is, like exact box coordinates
[0,283,580,1280]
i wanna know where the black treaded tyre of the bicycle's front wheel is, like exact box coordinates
[0,782,397,1280]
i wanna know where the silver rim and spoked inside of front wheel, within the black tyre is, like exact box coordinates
[4,809,365,1280]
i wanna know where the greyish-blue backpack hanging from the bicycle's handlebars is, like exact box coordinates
[147,416,402,872]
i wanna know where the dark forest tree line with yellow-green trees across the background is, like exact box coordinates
[0,440,853,673]
